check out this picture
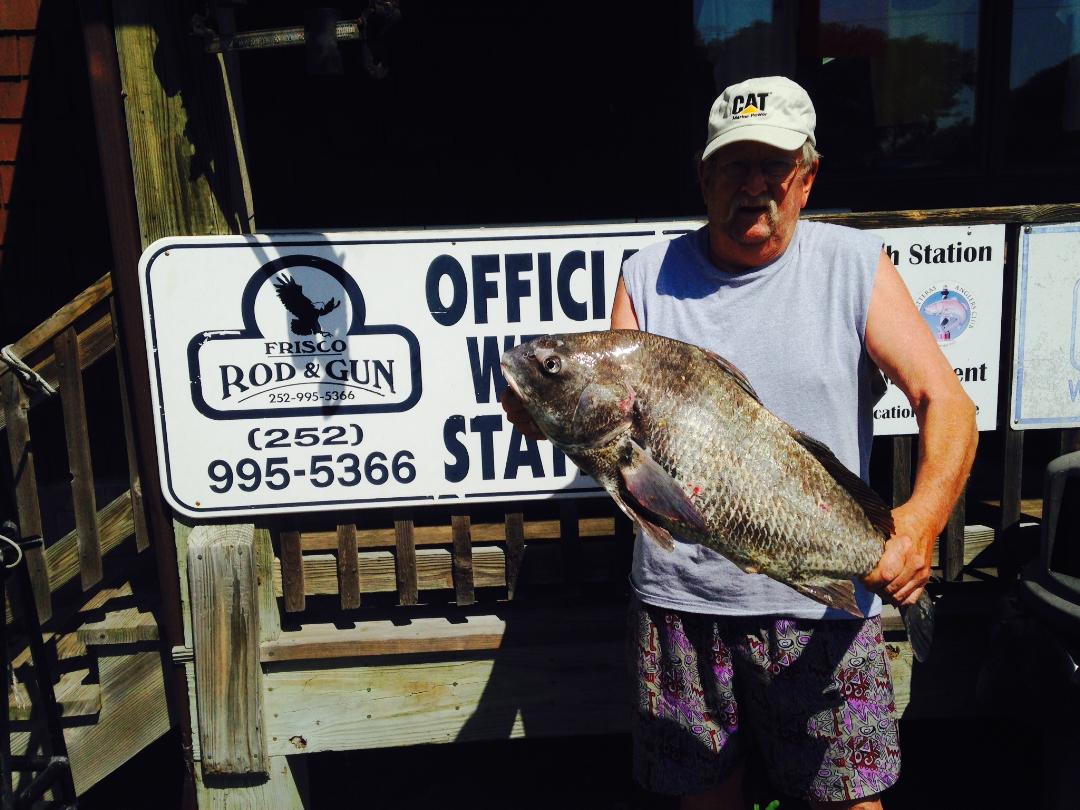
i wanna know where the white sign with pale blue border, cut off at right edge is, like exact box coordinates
[1010,222,1080,430]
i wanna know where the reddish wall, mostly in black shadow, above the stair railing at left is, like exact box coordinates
[0,0,111,345]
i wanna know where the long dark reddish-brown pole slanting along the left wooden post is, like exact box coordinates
[79,0,197,810]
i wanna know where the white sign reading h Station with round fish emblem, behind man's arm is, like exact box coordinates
[873,225,1005,435]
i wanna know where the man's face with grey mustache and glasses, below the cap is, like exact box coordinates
[699,141,818,267]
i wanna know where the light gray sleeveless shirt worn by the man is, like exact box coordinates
[622,221,881,619]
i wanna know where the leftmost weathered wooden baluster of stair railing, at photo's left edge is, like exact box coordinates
[0,374,53,622]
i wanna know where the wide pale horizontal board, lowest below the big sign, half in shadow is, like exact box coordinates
[265,639,630,754]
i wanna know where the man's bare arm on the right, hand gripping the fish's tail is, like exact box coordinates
[866,253,978,605]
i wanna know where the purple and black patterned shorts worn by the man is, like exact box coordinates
[629,603,900,801]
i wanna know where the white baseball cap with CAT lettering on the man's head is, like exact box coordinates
[701,76,818,160]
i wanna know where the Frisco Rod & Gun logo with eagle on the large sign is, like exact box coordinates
[188,254,421,419]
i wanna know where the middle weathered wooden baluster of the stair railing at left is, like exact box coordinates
[53,328,102,591]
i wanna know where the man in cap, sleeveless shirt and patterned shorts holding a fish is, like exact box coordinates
[503,77,977,810]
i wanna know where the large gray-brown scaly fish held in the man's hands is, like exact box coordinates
[502,329,933,660]
